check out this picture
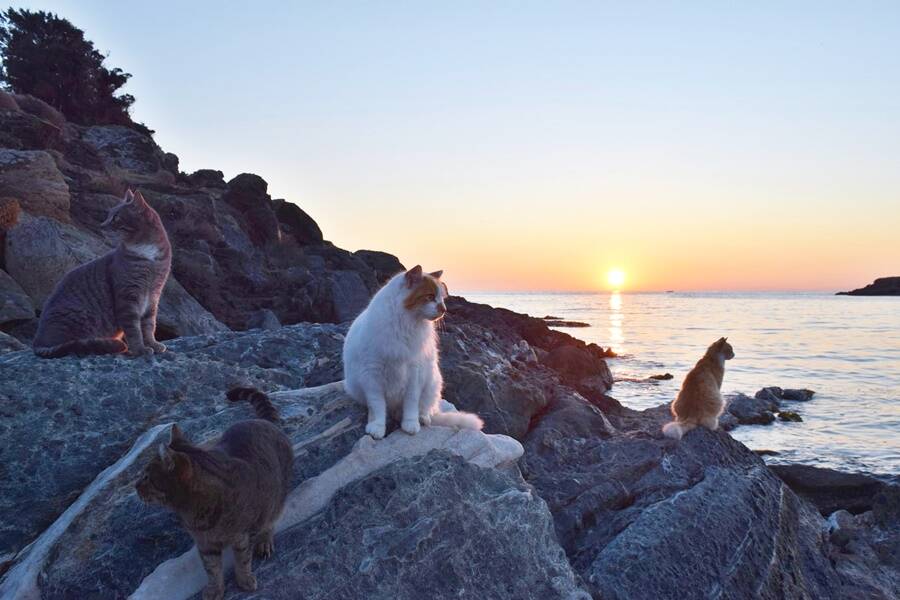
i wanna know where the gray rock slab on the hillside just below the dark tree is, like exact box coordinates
[81,125,175,185]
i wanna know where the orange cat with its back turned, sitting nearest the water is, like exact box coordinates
[663,338,734,440]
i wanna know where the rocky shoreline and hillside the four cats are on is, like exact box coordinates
[0,94,900,600]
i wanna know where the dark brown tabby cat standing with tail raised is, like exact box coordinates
[135,388,294,600]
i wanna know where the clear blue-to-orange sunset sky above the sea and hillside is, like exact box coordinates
[21,0,900,291]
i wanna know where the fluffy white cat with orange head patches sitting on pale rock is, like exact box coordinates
[344,266,483,439]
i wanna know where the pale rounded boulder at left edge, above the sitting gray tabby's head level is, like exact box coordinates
[0,148,70,221]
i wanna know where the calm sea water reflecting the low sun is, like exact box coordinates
[463,293,900,475]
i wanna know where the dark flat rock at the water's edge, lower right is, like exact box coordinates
[770,465,886,516]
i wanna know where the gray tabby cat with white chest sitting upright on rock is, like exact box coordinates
[34,190,172,358]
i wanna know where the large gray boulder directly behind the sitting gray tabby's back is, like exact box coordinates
[5,215,109,307]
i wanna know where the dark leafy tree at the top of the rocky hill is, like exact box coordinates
[0,8,145,129]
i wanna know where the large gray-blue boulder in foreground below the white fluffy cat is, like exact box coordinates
[214,451,589,600]
